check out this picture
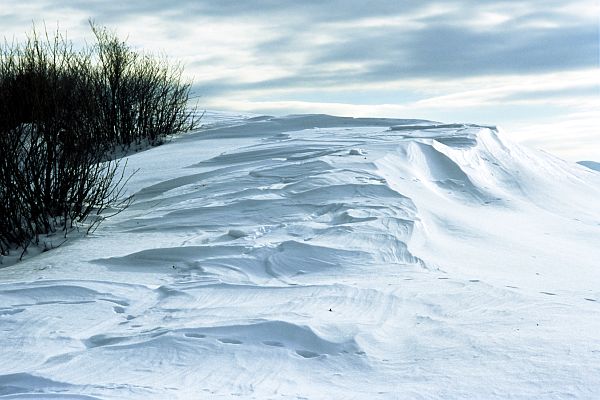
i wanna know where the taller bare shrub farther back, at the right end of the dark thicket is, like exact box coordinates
[91,23,197,146]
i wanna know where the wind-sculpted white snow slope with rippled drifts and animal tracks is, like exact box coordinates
[0,113,600,399]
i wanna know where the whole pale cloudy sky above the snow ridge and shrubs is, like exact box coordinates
[0,0,600,160]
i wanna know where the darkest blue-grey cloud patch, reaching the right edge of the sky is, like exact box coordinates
[370,26,598,77]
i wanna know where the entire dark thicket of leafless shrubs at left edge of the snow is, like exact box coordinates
[0,23,197,254]
